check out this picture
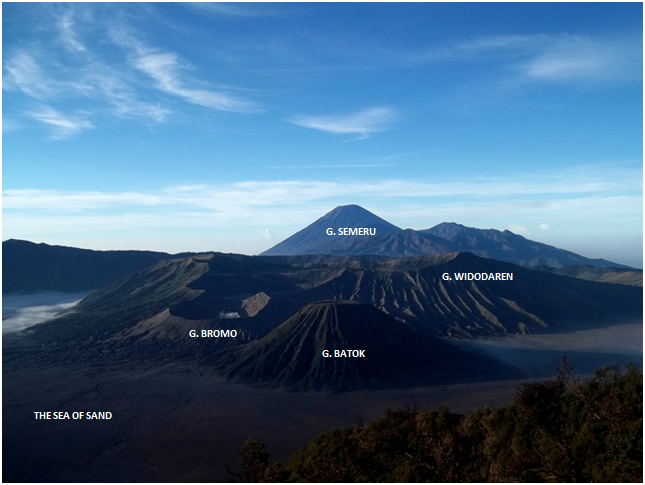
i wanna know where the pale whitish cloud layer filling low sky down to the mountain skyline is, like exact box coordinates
[2,164,643,264]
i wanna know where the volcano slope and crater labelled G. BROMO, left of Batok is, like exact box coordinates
[29,253,294,355]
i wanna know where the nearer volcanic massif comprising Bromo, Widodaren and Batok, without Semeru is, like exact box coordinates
[20,252,643,391]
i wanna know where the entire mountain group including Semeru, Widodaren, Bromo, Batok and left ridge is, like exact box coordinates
[3,206,643,391]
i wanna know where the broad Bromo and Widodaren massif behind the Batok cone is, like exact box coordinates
[33,253,643,347]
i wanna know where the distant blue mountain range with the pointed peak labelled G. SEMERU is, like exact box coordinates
[261,205,628,268]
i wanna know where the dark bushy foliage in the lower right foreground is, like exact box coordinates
[240,358,643,483]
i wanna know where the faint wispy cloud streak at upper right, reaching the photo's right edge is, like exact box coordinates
[350,33,643,84]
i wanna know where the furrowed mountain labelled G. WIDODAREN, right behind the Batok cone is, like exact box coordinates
[294,253,642,337]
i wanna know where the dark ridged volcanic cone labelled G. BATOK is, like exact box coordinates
[213,301,510,391]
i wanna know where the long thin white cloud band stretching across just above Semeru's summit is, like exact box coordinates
[3,166,642,212]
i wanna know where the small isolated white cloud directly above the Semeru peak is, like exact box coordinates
[288,107,396,138]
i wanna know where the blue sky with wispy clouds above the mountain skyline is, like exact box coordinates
[2,3,643,267]
